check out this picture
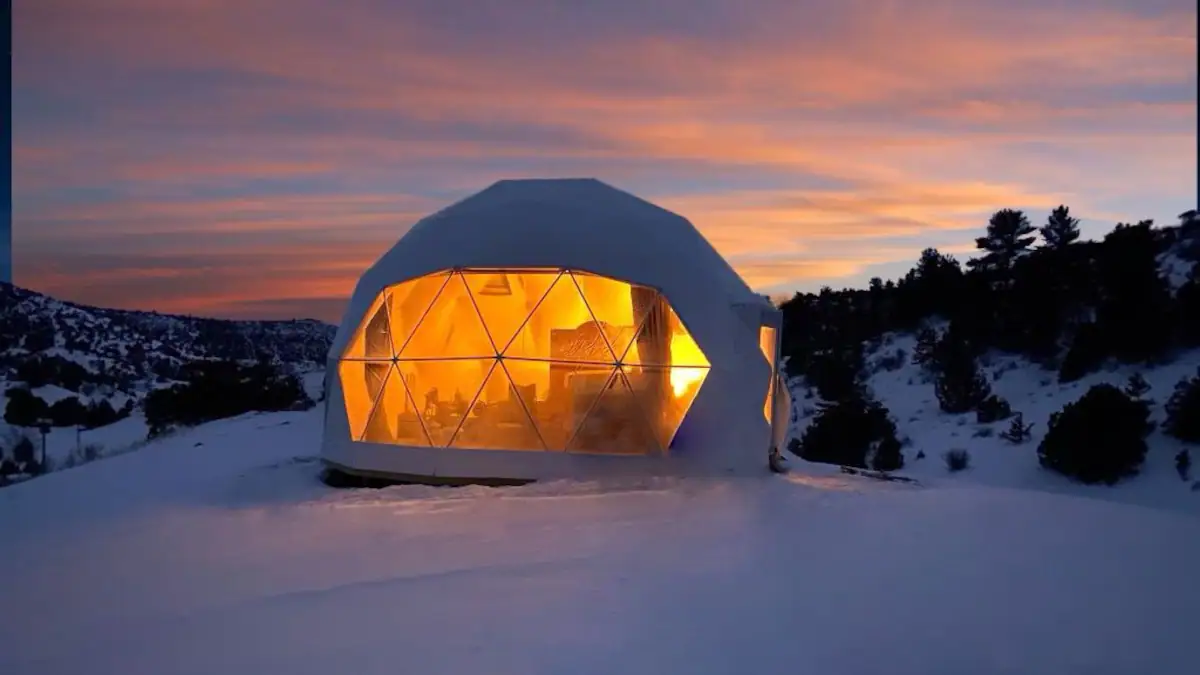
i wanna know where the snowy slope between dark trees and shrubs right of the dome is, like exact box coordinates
[791,335,1200,514]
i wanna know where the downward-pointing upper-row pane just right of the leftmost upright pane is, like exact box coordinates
[462,270,559,351]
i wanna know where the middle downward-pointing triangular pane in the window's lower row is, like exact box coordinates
[500,358,613,450]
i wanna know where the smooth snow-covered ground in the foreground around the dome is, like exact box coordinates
[0,401,1200,675]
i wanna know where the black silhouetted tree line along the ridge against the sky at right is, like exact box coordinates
[780,207,1200,382]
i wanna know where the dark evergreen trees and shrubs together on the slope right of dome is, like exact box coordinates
[781,207,1200,483]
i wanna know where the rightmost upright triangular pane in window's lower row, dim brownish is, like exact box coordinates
[566,371,661,455]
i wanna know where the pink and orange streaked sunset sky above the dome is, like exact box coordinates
[12,0,1196,321]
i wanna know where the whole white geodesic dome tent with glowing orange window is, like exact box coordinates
[322,180,791,482]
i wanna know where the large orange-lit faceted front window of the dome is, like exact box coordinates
[338,269,710,455]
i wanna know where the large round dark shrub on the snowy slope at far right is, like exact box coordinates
[1038,384,1153,485]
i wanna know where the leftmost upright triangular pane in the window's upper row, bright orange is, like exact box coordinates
[400,273,496,359]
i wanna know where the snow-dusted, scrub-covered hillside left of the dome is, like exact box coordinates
[0,283,336,473]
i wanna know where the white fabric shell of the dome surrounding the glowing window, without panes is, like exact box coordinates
[323,179,787,480]
